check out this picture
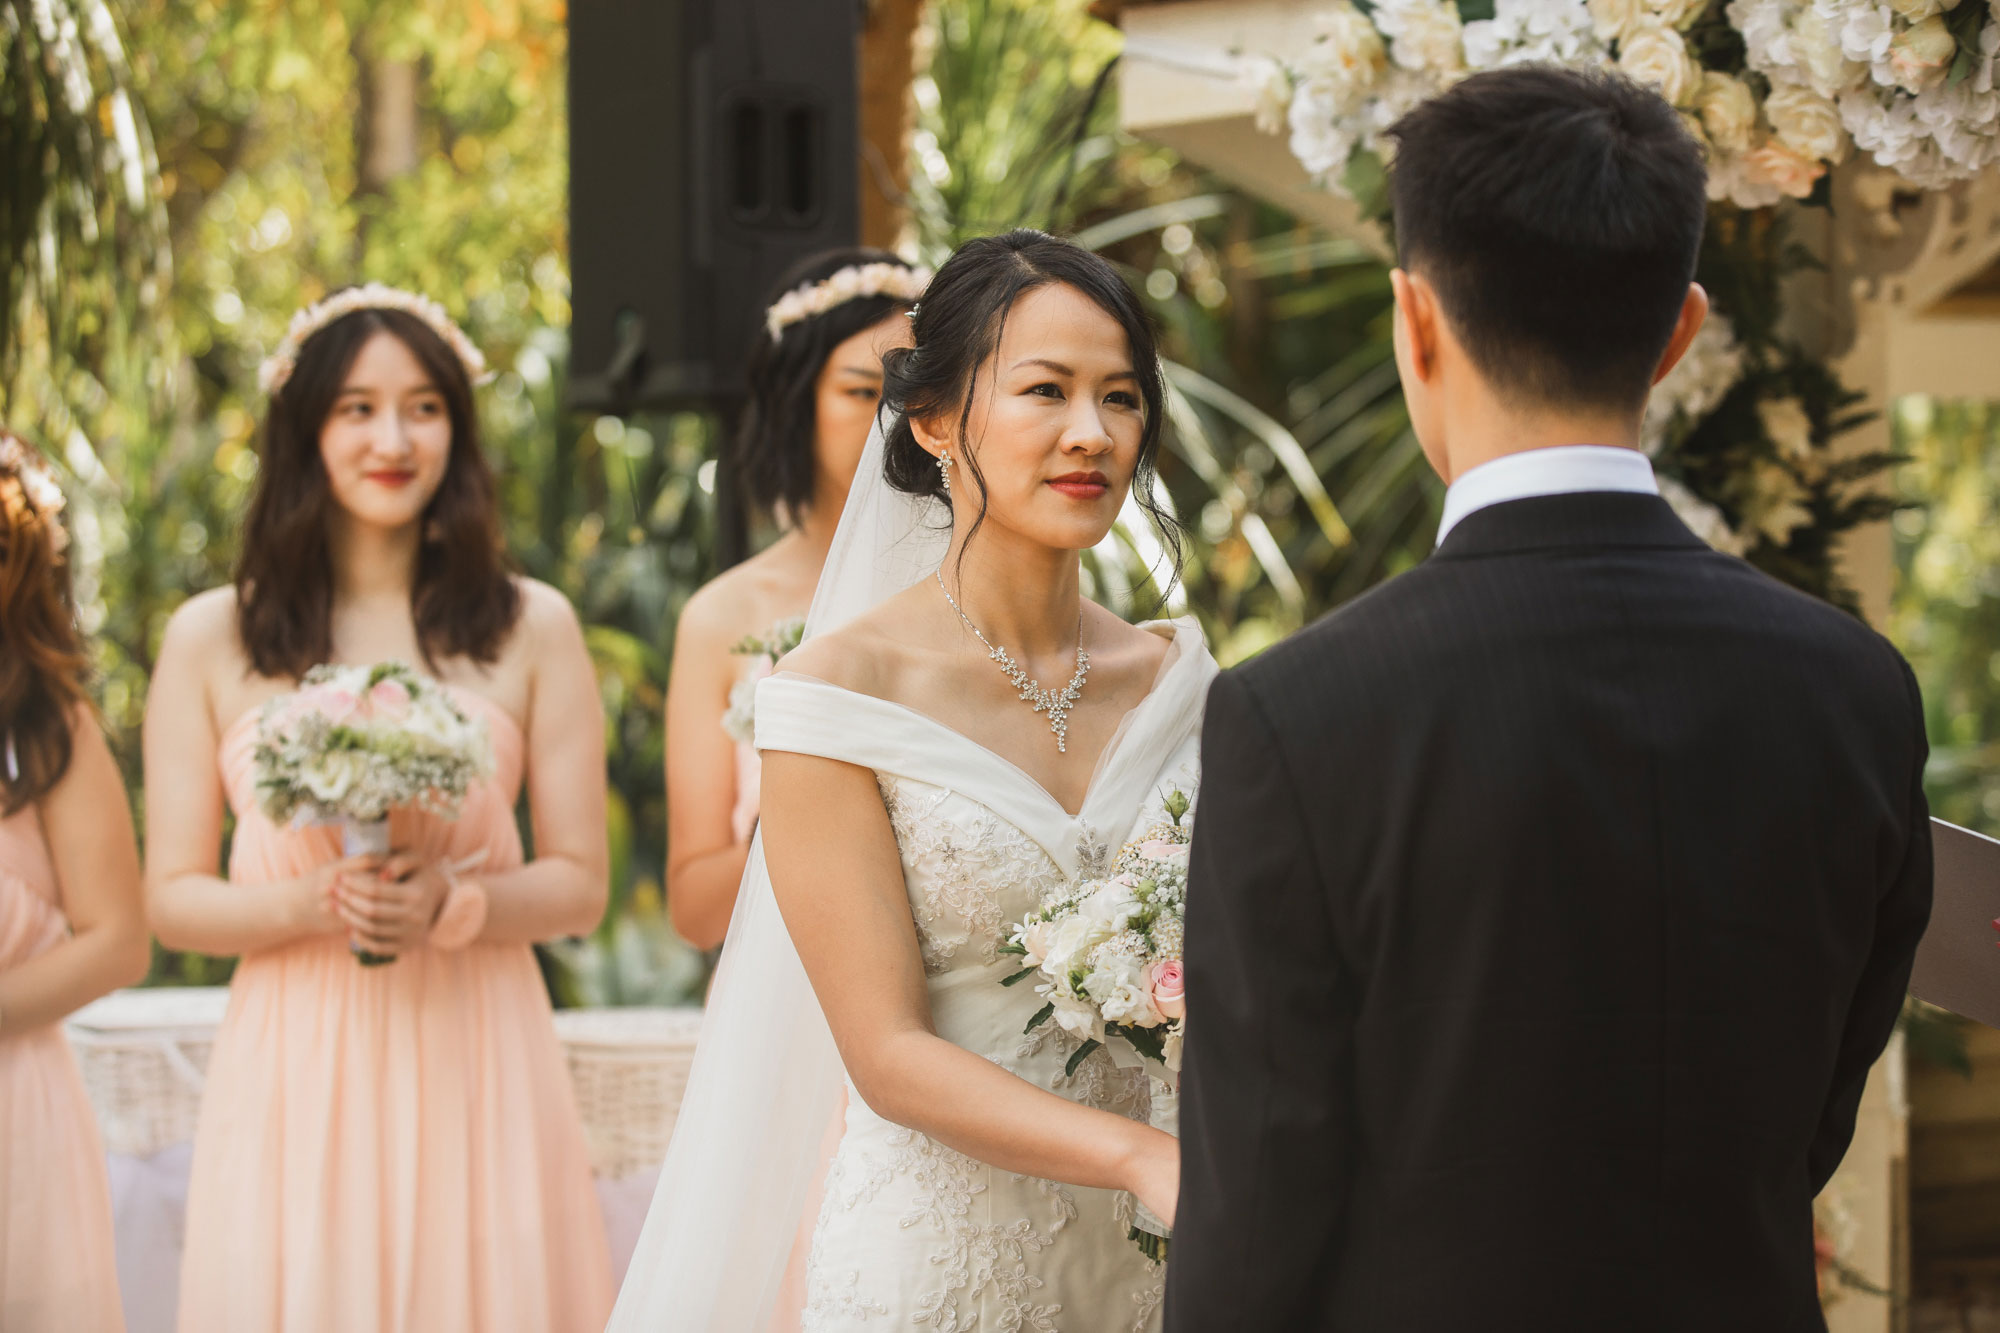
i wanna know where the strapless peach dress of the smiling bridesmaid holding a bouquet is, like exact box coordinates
[180,691,612,1333]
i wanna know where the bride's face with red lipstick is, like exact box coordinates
[920,282,1144,550]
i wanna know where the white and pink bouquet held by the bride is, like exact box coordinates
[1000,789,1192,1259]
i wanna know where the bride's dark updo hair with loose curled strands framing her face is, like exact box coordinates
[882,228,1180,578]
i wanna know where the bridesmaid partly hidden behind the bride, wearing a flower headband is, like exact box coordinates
[666,248,930,949]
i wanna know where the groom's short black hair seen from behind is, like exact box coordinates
[1390,66,1708,410]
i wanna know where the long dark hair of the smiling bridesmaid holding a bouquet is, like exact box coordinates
[236,310,520,679]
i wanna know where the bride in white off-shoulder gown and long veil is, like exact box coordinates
[612,230,1216,1333]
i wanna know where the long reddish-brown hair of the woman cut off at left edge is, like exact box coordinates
[0,426,90,815]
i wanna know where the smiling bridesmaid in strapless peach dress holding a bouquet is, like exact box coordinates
[146,284,612,1333]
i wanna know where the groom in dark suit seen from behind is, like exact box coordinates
[1166,68,1930,1333]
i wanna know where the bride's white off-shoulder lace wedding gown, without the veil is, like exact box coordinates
[756,622,1214,1333]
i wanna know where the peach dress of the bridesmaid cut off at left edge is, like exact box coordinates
[0,805,124,1333]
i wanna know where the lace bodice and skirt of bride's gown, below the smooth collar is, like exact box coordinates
[802,775,1164,1333]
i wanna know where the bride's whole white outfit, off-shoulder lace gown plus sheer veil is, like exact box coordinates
[610,426,1216,1333]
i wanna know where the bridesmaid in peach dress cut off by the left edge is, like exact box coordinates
[0,430,148,1333]
